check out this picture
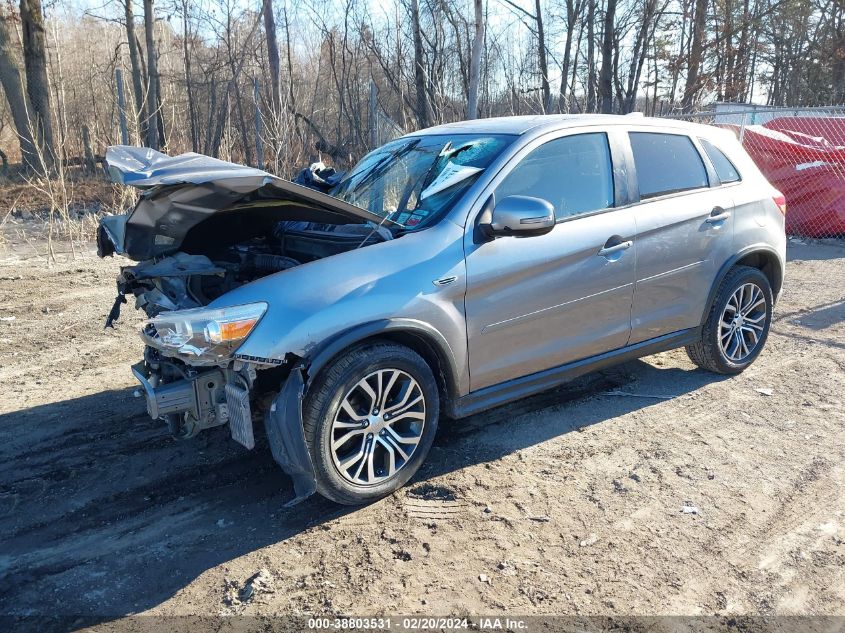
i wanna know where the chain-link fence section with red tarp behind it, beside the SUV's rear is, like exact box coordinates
[669,104,845,237]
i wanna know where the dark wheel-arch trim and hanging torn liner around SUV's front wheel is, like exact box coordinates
[265,318,457,506]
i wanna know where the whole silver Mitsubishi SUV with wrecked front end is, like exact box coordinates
[98,116,786,504]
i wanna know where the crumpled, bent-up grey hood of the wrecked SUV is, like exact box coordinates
[97,145,392,261]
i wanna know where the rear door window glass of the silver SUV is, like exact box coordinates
[629,132,708,199]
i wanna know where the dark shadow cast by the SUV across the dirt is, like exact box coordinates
[0,361,716,622]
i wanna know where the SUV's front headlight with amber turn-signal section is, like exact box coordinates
[141,302,267,361]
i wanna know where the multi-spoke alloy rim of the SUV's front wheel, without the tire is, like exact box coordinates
[330,369,426,486]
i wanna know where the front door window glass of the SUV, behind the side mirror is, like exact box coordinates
[496,133,614,220]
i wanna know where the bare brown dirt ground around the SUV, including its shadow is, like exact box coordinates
[0,226,845,626]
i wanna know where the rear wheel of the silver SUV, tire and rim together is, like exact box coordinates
[686,266,773,374]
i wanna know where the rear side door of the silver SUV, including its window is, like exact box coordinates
[628,129,733,344]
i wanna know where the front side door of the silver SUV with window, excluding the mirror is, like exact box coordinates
[465,133,635,391]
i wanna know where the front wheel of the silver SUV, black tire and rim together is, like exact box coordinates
[302,342,440,505]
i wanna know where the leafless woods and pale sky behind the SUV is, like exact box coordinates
[0,0,845,176]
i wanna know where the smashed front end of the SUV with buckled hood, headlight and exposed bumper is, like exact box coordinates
[97,147,393,500]
